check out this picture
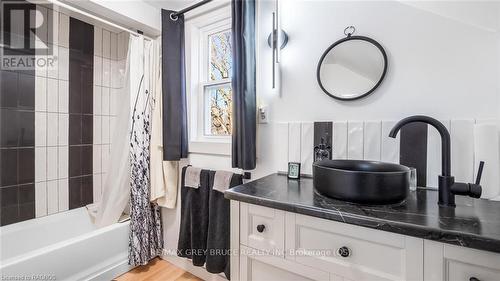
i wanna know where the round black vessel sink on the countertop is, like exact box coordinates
[313,160,410,204]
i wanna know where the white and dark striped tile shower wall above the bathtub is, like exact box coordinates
[0,2,128,225]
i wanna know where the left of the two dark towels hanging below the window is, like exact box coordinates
[177,167,210,266]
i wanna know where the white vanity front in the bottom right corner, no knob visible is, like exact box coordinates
[424,240,500,281]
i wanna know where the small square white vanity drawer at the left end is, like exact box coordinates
[240,203,285,255]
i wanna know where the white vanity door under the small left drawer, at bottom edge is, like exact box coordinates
[240,246,329,281]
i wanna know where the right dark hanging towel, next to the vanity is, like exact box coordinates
[206,171,243,279]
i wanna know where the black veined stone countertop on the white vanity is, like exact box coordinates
[225,174,500,253]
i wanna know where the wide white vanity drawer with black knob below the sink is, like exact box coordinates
[286,213,423,281]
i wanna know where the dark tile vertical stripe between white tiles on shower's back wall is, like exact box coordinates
[68,18,94,209]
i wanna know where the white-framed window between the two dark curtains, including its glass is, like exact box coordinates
[185,5,233,152]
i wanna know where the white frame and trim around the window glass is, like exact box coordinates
[185,2,231,155]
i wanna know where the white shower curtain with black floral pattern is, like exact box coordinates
[129,36,163,266]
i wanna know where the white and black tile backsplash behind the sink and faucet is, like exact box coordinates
[274,120,500,199]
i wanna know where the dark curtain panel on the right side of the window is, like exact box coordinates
[231,0,257,170]
